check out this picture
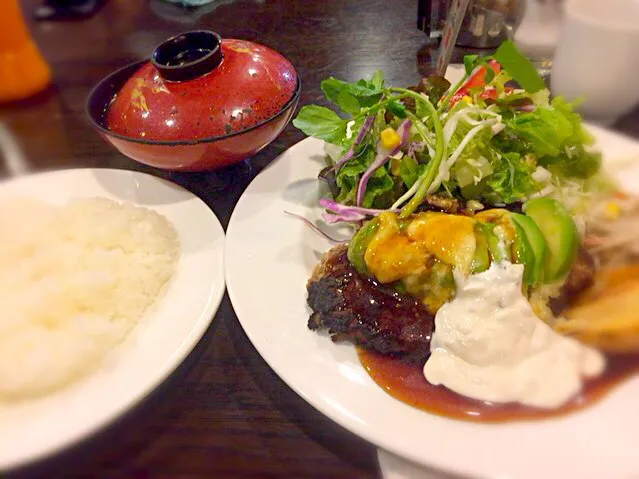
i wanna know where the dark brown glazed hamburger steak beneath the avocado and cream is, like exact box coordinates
[306,245,595,364]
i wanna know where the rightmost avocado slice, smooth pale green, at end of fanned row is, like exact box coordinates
[523,198,579,283]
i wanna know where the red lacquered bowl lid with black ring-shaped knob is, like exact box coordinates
[104,30,298,142]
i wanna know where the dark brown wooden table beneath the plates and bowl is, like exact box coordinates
[0,0,639,478]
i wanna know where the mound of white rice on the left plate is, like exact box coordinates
[0,198,180,402]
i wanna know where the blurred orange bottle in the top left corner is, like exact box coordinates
[0,0,51,102]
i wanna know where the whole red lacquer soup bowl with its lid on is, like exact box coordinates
[86,30,301,171]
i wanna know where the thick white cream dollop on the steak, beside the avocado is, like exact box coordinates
[424,263,605,408]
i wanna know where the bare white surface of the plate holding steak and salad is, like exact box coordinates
[226,127,639,479]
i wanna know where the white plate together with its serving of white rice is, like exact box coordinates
[0,169,224,471]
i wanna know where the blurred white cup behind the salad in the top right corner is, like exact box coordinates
[550,0,639,124]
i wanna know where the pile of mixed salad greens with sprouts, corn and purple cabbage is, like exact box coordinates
[293,42,601,222]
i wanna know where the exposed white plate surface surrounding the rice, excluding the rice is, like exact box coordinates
[0,169,224,471]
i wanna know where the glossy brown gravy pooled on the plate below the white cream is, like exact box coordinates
[358,349,639,422]
